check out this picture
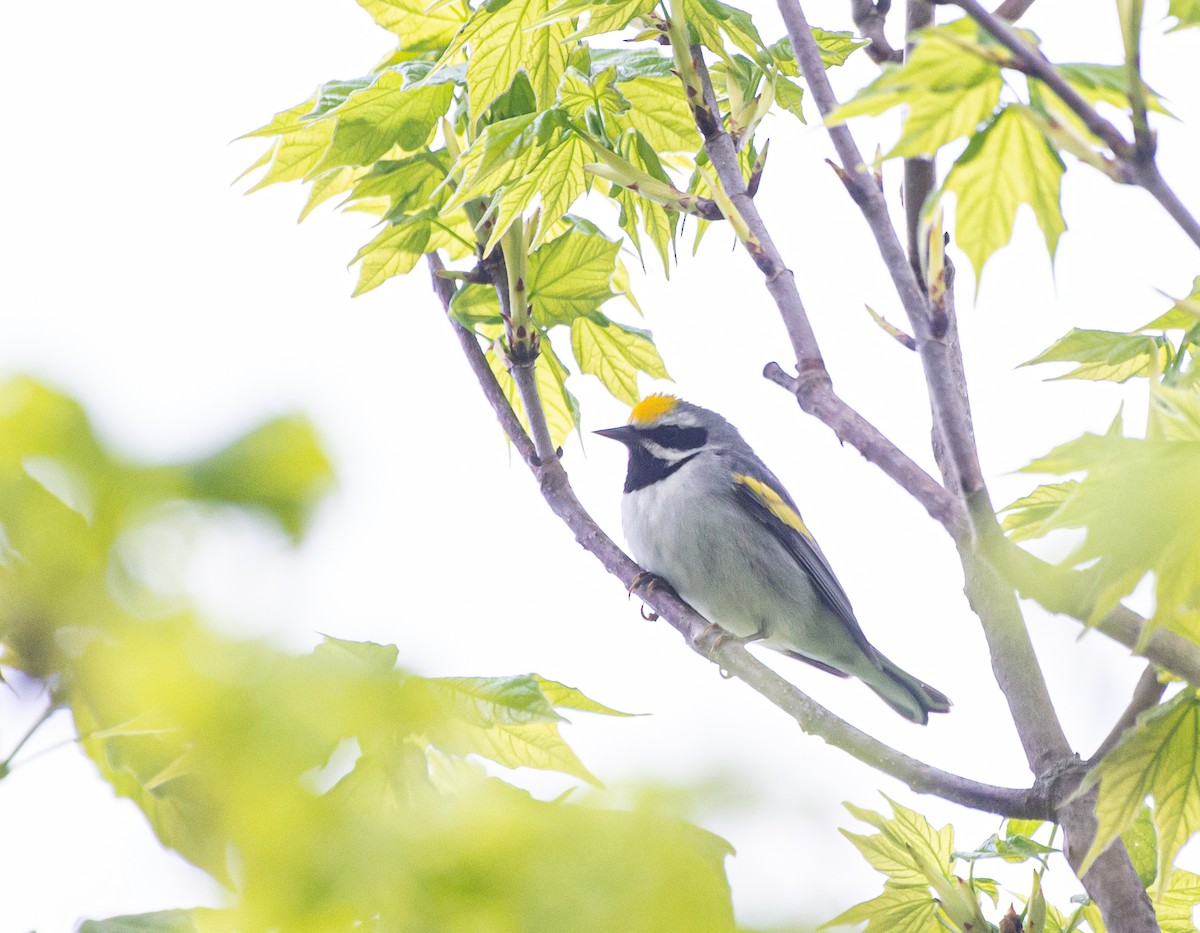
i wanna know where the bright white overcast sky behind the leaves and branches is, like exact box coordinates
[0,0,1200,933]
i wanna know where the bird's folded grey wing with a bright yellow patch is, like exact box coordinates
[733,469,875,657]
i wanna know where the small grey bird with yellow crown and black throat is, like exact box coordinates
[595,393,950,726]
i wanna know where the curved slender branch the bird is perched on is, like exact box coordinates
[427,255,1051,819]
